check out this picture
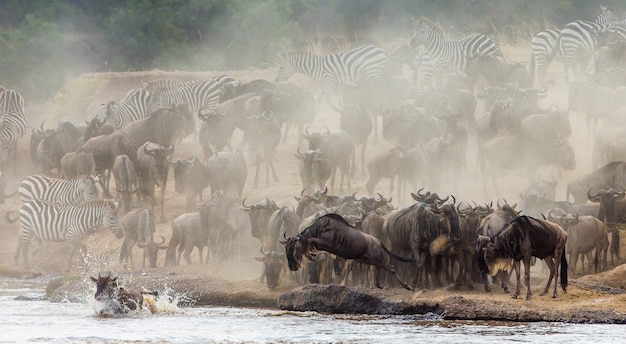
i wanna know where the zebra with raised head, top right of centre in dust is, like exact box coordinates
[411,18,502,88]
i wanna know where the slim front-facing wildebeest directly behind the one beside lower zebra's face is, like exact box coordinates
[135,141,174,221]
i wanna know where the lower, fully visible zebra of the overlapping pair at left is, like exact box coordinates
[9,200,124,271]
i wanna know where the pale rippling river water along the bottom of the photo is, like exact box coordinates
[0,277,626,344]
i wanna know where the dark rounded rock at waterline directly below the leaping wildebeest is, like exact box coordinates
[278,284,442,314]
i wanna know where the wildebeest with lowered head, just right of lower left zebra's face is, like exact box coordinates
[120,208,167,269]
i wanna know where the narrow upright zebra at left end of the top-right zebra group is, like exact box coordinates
[530,29,561,85]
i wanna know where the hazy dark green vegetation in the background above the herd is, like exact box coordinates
[0,0,623,100]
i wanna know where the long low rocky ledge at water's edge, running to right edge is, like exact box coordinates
[278,285,626,324]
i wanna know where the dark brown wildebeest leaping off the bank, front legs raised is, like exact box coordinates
[281,214,414,290]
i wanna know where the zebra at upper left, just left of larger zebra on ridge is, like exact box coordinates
[102,88,153,129]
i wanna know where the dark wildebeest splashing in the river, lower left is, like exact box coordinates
[91,272,159,314]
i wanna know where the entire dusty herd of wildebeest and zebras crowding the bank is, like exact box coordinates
[0,6,626,306]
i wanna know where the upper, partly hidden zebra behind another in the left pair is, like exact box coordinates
[18,175,98,205]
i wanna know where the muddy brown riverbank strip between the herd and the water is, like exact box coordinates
[7,265,626,324]
